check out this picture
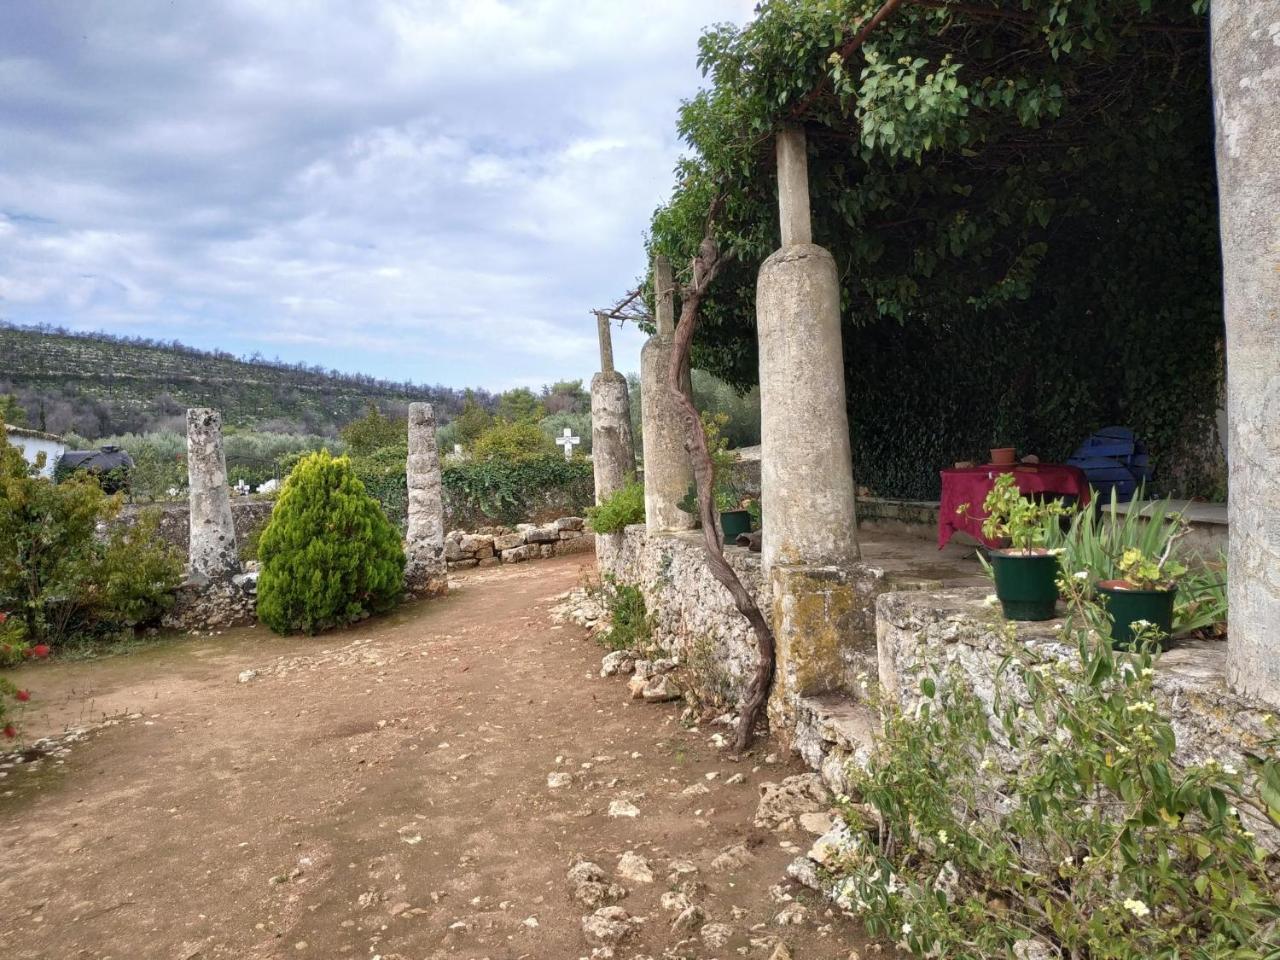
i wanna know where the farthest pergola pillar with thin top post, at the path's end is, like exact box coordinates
[591,312,636,572]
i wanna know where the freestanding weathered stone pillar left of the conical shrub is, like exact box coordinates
[187,407,241,580]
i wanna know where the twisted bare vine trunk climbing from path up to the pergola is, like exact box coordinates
[667,200,776,753]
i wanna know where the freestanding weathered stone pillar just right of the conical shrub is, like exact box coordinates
[404,403,449,596]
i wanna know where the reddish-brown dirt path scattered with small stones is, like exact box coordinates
[0,557,880,960]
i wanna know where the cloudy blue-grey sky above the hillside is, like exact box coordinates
[0,0,753,389]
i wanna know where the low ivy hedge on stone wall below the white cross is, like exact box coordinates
[445,455,595,525]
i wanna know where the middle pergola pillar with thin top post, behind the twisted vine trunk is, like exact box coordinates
[640,256,695,534]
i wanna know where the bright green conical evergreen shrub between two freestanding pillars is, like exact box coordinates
[257,451,404,634]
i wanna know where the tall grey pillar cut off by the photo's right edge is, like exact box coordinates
[1210,0,1280,707]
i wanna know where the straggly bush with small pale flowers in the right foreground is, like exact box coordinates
[833,583,1280,960]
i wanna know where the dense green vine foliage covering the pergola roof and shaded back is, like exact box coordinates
[650,0,1222,498]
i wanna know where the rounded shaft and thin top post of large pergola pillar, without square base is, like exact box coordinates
[755,128,858,570]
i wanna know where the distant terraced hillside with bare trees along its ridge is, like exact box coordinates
[0,324,493,438]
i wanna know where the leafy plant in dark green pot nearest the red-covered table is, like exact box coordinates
[956,474,1069,620]
